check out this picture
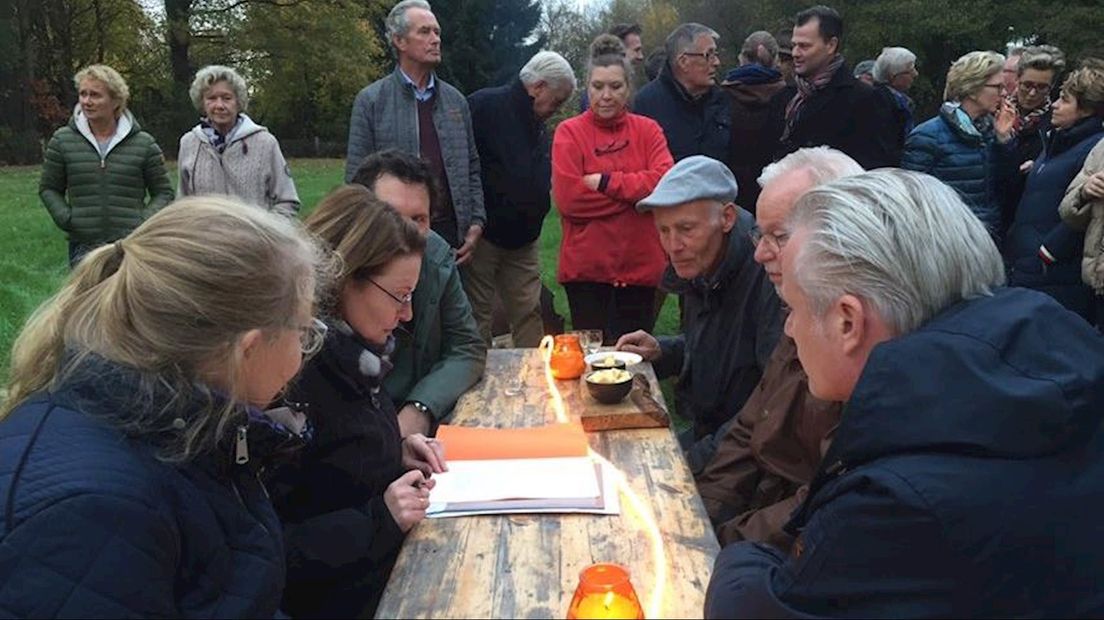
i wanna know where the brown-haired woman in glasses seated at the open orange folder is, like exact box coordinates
[269,185,445,618]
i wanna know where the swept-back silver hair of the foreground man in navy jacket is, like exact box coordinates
[787,169,1005,335]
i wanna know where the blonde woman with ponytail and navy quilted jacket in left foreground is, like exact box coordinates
[0,197,329,618]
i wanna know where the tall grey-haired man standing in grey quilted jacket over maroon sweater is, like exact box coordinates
[346,0,487,260]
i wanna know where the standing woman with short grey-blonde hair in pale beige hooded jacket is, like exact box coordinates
[177,65,299,217]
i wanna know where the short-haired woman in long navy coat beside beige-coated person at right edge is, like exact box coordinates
[1005,65,1104,321]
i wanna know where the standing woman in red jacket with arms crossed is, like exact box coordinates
[552,34,675,342]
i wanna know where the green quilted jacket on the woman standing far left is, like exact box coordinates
[39,104,173,245]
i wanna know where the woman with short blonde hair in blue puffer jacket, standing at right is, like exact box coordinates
[901,52,1016,246]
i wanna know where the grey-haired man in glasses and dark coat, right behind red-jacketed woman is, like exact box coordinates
[633,23,732,163]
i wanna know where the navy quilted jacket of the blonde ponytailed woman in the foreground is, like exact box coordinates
[0,364,284,618]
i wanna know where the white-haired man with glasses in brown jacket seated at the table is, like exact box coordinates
[697,147,863,550]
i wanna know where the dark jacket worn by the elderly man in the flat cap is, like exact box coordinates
[656,210,782,465]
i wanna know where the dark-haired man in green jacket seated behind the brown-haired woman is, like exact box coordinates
[352,149,487,437]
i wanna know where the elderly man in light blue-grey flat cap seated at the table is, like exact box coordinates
[617,156,782,467]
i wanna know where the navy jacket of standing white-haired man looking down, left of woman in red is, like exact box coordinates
[468,78,552,249]
